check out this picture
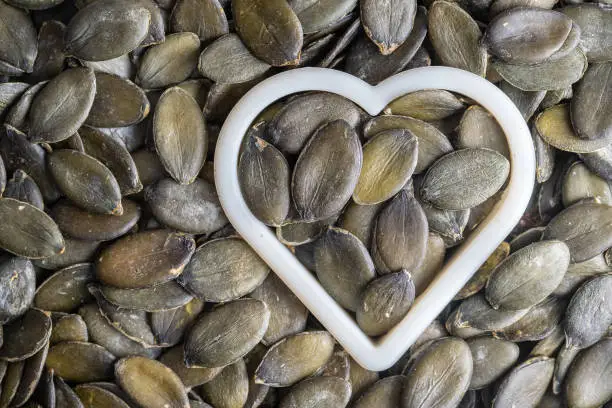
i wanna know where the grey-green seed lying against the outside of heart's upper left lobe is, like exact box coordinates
[198,34,270,84]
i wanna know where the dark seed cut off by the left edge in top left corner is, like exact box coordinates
[0,3,38,75]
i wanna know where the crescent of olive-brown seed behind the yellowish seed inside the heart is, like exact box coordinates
[364,115,452,174]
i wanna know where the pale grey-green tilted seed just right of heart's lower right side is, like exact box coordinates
[485,241,570,310]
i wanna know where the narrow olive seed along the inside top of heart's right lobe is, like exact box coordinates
[385,89,465,122]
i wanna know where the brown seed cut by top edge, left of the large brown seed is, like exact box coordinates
[170,0,229,42]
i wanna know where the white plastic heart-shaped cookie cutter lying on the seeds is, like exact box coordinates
[214,67,535,371]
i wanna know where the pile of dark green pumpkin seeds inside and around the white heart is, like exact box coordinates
[0,0,612,408]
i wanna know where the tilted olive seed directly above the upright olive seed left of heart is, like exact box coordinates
[136,33,200,89]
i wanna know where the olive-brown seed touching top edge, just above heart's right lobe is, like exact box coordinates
[428,0,487,77]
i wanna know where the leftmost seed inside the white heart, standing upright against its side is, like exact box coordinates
[238,132,291,226]
